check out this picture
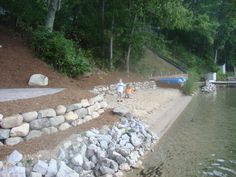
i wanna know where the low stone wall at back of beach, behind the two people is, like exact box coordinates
[91,81,157,95]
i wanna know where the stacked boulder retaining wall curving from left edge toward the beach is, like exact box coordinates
[0,95,107,145]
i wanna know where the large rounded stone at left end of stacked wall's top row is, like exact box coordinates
[1,114,23,128]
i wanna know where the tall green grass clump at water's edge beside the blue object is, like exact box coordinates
[183,70,200,95]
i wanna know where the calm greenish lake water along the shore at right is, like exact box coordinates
[127,88,236,177]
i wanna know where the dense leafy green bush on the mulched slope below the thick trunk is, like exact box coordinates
[32,29,90,77]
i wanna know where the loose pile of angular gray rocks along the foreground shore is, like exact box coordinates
[0,113,157,177]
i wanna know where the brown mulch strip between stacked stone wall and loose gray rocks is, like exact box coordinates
[0,110,119,160]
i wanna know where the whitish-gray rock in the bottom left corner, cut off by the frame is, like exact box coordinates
[0,166,26,177]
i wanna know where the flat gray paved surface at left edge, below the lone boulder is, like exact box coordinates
[0,88,64,102]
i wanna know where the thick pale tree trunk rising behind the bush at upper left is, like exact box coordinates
[45,0,59,32]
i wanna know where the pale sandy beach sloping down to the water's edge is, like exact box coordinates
[106,88,191,137]
